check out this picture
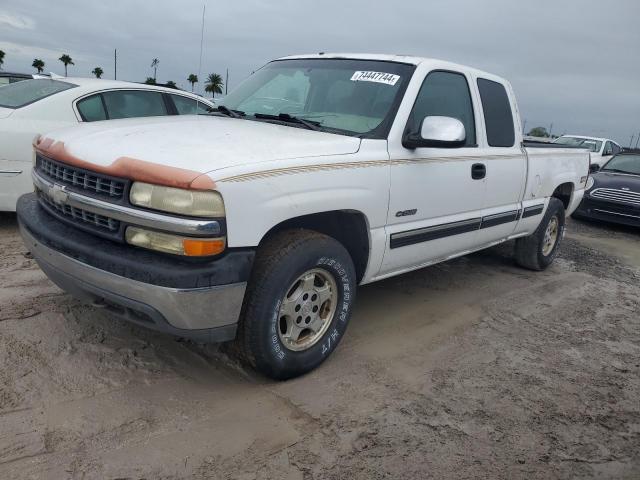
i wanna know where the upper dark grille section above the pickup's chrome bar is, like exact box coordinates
[36,155,126,199]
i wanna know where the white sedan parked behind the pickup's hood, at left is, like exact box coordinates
[0,78,213,211]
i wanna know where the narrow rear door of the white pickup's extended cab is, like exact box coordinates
[476,77,527,247]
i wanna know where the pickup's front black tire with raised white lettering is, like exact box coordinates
[236,229,356,380]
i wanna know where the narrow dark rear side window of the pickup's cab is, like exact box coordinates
[478,78,516,147]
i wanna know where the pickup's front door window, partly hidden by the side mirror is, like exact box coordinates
[409,71,476,147]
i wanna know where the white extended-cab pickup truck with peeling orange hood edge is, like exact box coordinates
[17,54,589,379]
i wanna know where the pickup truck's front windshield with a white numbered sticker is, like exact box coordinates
[219,59,415,138]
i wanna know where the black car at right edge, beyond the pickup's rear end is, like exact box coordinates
[573,153,640,226]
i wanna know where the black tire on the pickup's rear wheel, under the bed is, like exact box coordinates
[515,197,565,271]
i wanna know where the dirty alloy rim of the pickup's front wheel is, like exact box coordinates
[277,268,338,351]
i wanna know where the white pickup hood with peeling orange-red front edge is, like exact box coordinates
[36,115,360,188]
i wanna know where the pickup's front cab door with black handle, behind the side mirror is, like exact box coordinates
[380,70,485,275]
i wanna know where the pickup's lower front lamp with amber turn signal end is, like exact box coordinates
[125,227,226,257]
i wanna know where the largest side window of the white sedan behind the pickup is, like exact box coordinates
[102,90,167,120]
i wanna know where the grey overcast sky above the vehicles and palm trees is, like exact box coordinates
[0,0,640,146]
